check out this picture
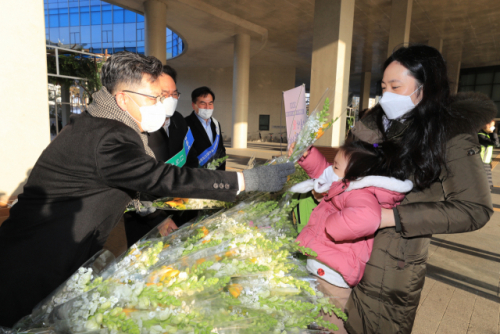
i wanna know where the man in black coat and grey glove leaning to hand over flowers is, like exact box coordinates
[0,52,294,327]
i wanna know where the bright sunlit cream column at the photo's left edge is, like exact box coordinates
[0,0,50,207]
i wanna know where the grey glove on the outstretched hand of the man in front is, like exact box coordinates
[243,162,295,192]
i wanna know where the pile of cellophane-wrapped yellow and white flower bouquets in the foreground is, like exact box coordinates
[14,187,345,334]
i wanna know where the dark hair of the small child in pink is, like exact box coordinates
[337,140,405,181]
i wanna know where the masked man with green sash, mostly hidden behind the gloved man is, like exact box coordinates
[123,65,198,247]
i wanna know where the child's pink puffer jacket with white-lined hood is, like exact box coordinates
[297,147,413,287]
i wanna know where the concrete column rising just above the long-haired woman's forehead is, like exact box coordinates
[387,0,413,57]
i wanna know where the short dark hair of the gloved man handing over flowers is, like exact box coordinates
[101,51,163,95]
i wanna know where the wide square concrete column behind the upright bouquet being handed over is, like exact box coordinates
[310,0,354,147]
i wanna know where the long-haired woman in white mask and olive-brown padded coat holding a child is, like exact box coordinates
[345,45,496,334]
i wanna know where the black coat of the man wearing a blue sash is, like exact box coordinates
[185,111,226,170]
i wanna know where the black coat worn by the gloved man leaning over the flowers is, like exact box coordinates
[0,113,238,327]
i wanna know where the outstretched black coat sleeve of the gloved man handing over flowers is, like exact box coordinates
[95,122,238,202]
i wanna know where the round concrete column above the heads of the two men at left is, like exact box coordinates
[144,0,167,64]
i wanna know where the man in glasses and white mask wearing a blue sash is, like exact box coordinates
[186,87,226,170]
